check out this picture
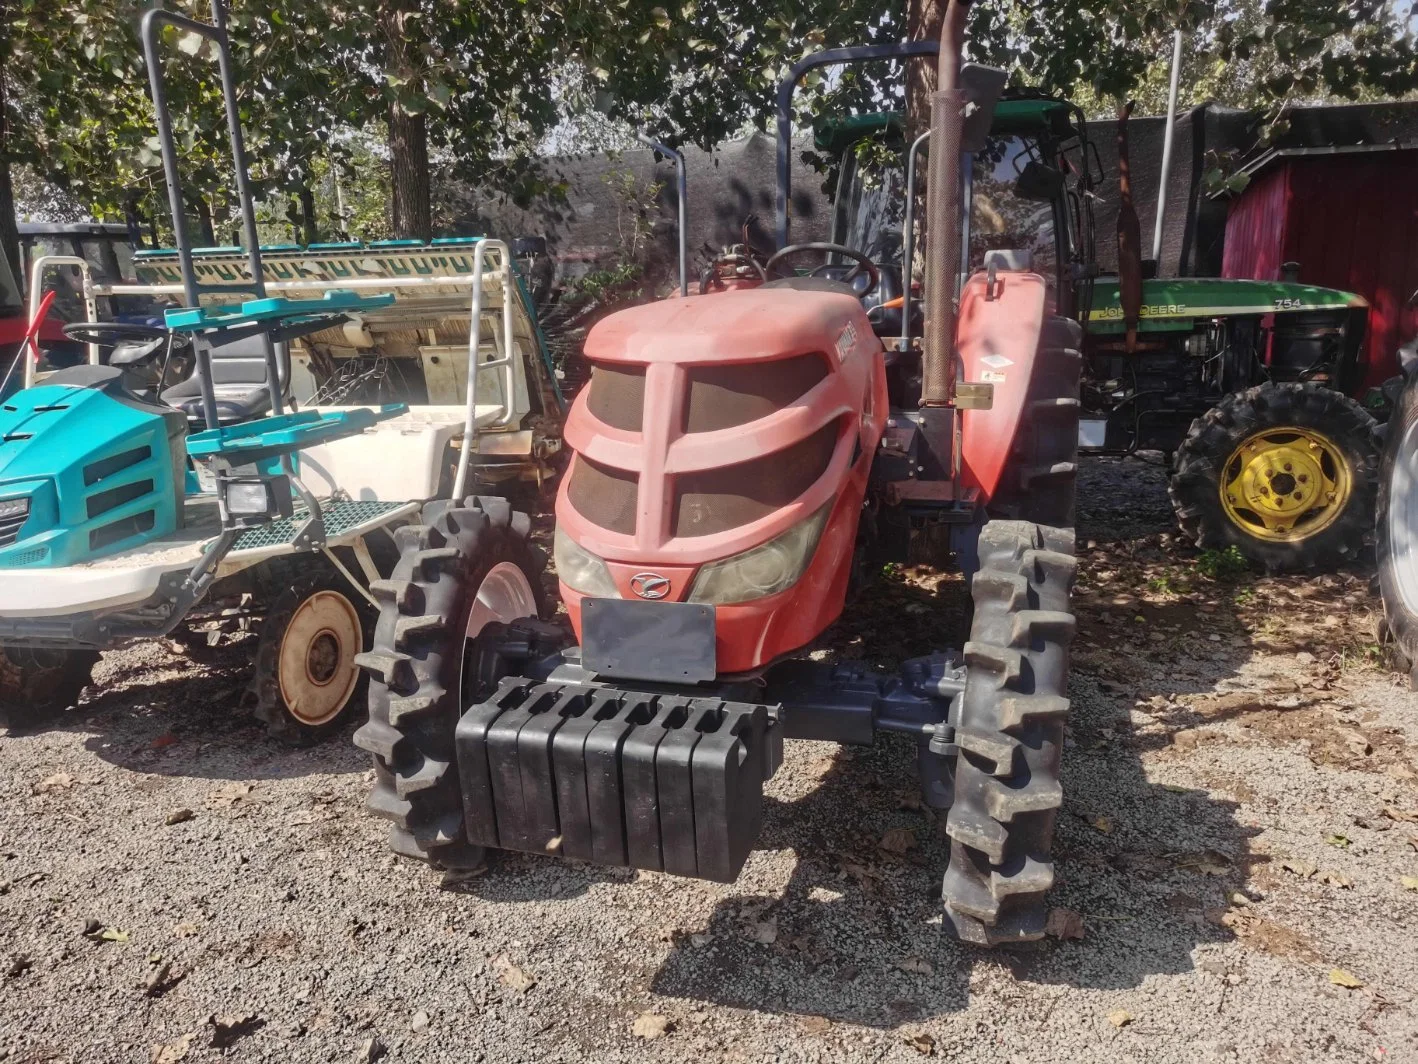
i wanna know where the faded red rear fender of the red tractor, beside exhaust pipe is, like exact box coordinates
[956,271,1048,502]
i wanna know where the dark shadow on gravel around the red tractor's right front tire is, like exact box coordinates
[652,462,1263,1027]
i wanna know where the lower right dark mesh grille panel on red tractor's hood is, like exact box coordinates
[675,421,841,536]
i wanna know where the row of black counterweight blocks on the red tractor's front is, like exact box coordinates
[457,678,783,882]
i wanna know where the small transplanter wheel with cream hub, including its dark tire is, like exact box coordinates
[250,579,369,746]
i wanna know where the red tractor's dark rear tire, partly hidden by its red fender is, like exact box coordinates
[988,318,1083,528]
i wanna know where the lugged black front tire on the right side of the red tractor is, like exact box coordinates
[942,521,1078,946]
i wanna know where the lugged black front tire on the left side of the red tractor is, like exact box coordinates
[355,497,547,868]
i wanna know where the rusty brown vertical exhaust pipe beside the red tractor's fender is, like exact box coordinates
[920,0,973,407]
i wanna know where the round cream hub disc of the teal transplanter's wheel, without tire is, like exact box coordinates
[279,592,363,726]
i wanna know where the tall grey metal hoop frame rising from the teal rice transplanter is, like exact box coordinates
[142,0,285,428]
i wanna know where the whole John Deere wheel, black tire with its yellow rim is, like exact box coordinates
[1168,383,1378,573]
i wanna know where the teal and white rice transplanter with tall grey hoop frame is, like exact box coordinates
[0,0,526,743]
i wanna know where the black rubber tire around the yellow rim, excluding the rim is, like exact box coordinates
[1168,383,1380,573]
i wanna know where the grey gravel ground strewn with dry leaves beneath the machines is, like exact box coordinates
[0,461,1418,1064]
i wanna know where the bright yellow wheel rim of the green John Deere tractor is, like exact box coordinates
[1221,427,1354,543]
